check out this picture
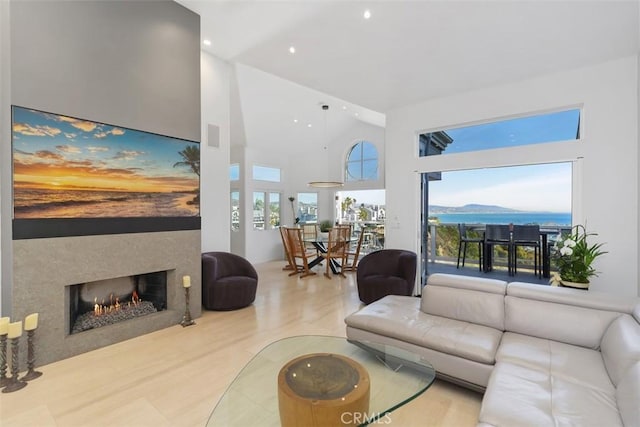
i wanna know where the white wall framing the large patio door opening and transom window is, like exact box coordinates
[386,55,639,295]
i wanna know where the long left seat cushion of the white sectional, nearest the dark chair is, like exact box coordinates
[345,295,502,364]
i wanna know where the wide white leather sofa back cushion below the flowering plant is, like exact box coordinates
[505,282,634,349]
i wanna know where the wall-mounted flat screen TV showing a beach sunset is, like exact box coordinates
[12,106,200,239]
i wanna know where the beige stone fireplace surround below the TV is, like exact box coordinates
[11,230,202,365]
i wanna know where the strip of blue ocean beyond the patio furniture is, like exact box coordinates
[429,212,571,226]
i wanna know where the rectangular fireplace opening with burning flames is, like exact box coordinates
[69,271,167,334]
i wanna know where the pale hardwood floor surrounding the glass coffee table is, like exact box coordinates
[0,262,482,427]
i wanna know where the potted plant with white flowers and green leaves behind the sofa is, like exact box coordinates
[549,225,607,289]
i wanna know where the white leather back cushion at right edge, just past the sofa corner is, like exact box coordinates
[600,314,640,388]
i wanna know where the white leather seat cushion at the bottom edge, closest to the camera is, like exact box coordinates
[479,362,622,427]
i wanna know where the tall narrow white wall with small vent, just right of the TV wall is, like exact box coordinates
[200,51,232,252]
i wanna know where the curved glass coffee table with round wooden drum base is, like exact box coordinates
[207,335,436,427]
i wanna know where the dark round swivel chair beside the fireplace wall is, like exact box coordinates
[202,252,258,310]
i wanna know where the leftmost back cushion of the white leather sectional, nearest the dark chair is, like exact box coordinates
[420,274,507,331]
